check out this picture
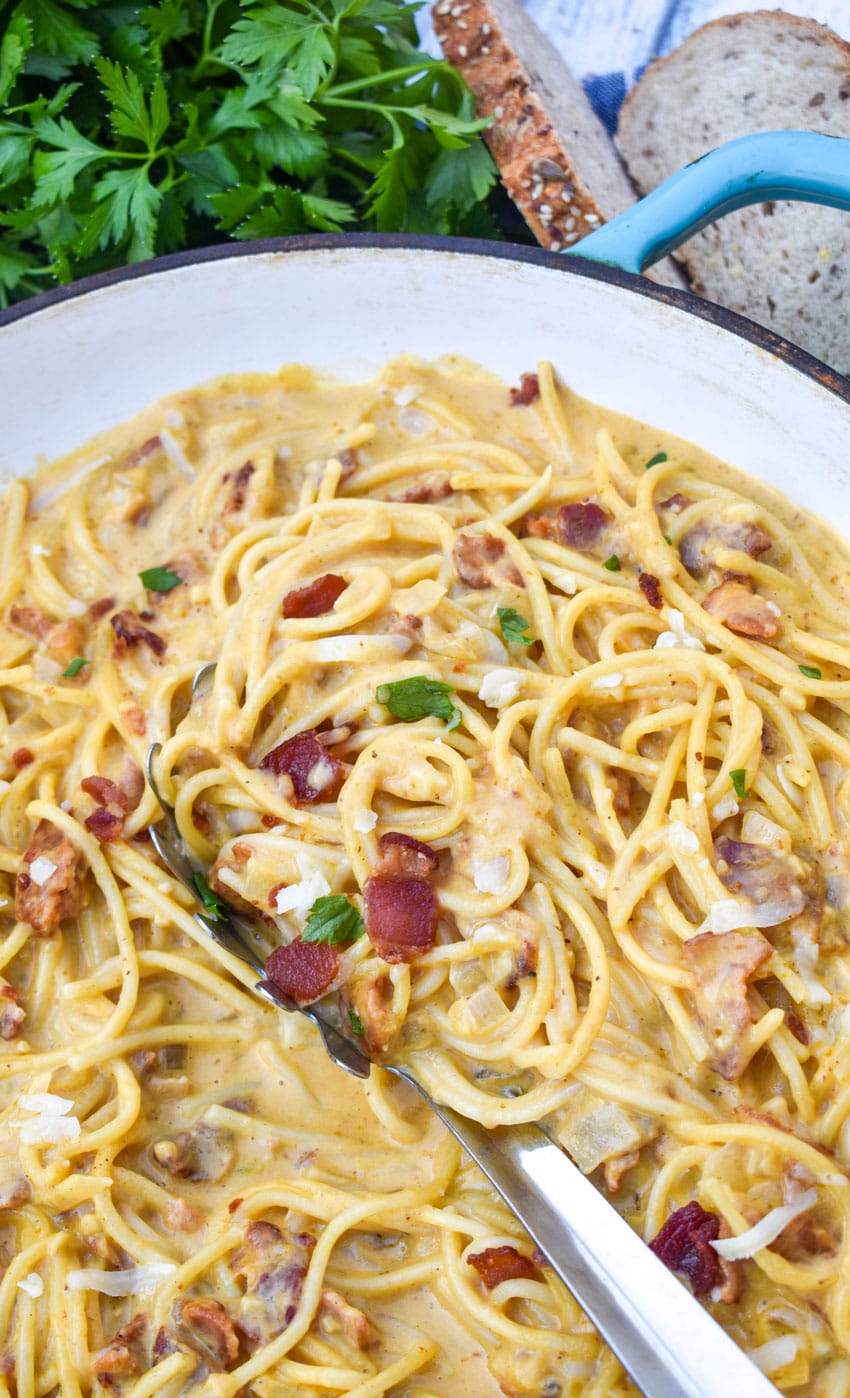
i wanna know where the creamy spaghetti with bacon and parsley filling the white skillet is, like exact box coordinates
[0,359,850,1398]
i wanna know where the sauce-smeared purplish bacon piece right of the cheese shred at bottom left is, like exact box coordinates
[231,1219,316,1343]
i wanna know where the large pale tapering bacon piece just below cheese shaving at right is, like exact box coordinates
[682,932,773,1082]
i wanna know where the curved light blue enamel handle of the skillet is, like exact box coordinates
[569,131,850,273]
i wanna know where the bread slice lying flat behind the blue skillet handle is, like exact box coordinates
[617,10,850,373]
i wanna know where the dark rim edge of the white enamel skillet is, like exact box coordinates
[0,233,850,404]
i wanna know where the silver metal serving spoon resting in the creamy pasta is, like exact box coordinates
[145,743,777,1398]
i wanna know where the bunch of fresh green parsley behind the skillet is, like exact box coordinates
[0,0,496,305]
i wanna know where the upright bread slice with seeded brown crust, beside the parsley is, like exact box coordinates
[432,0,684,287]
